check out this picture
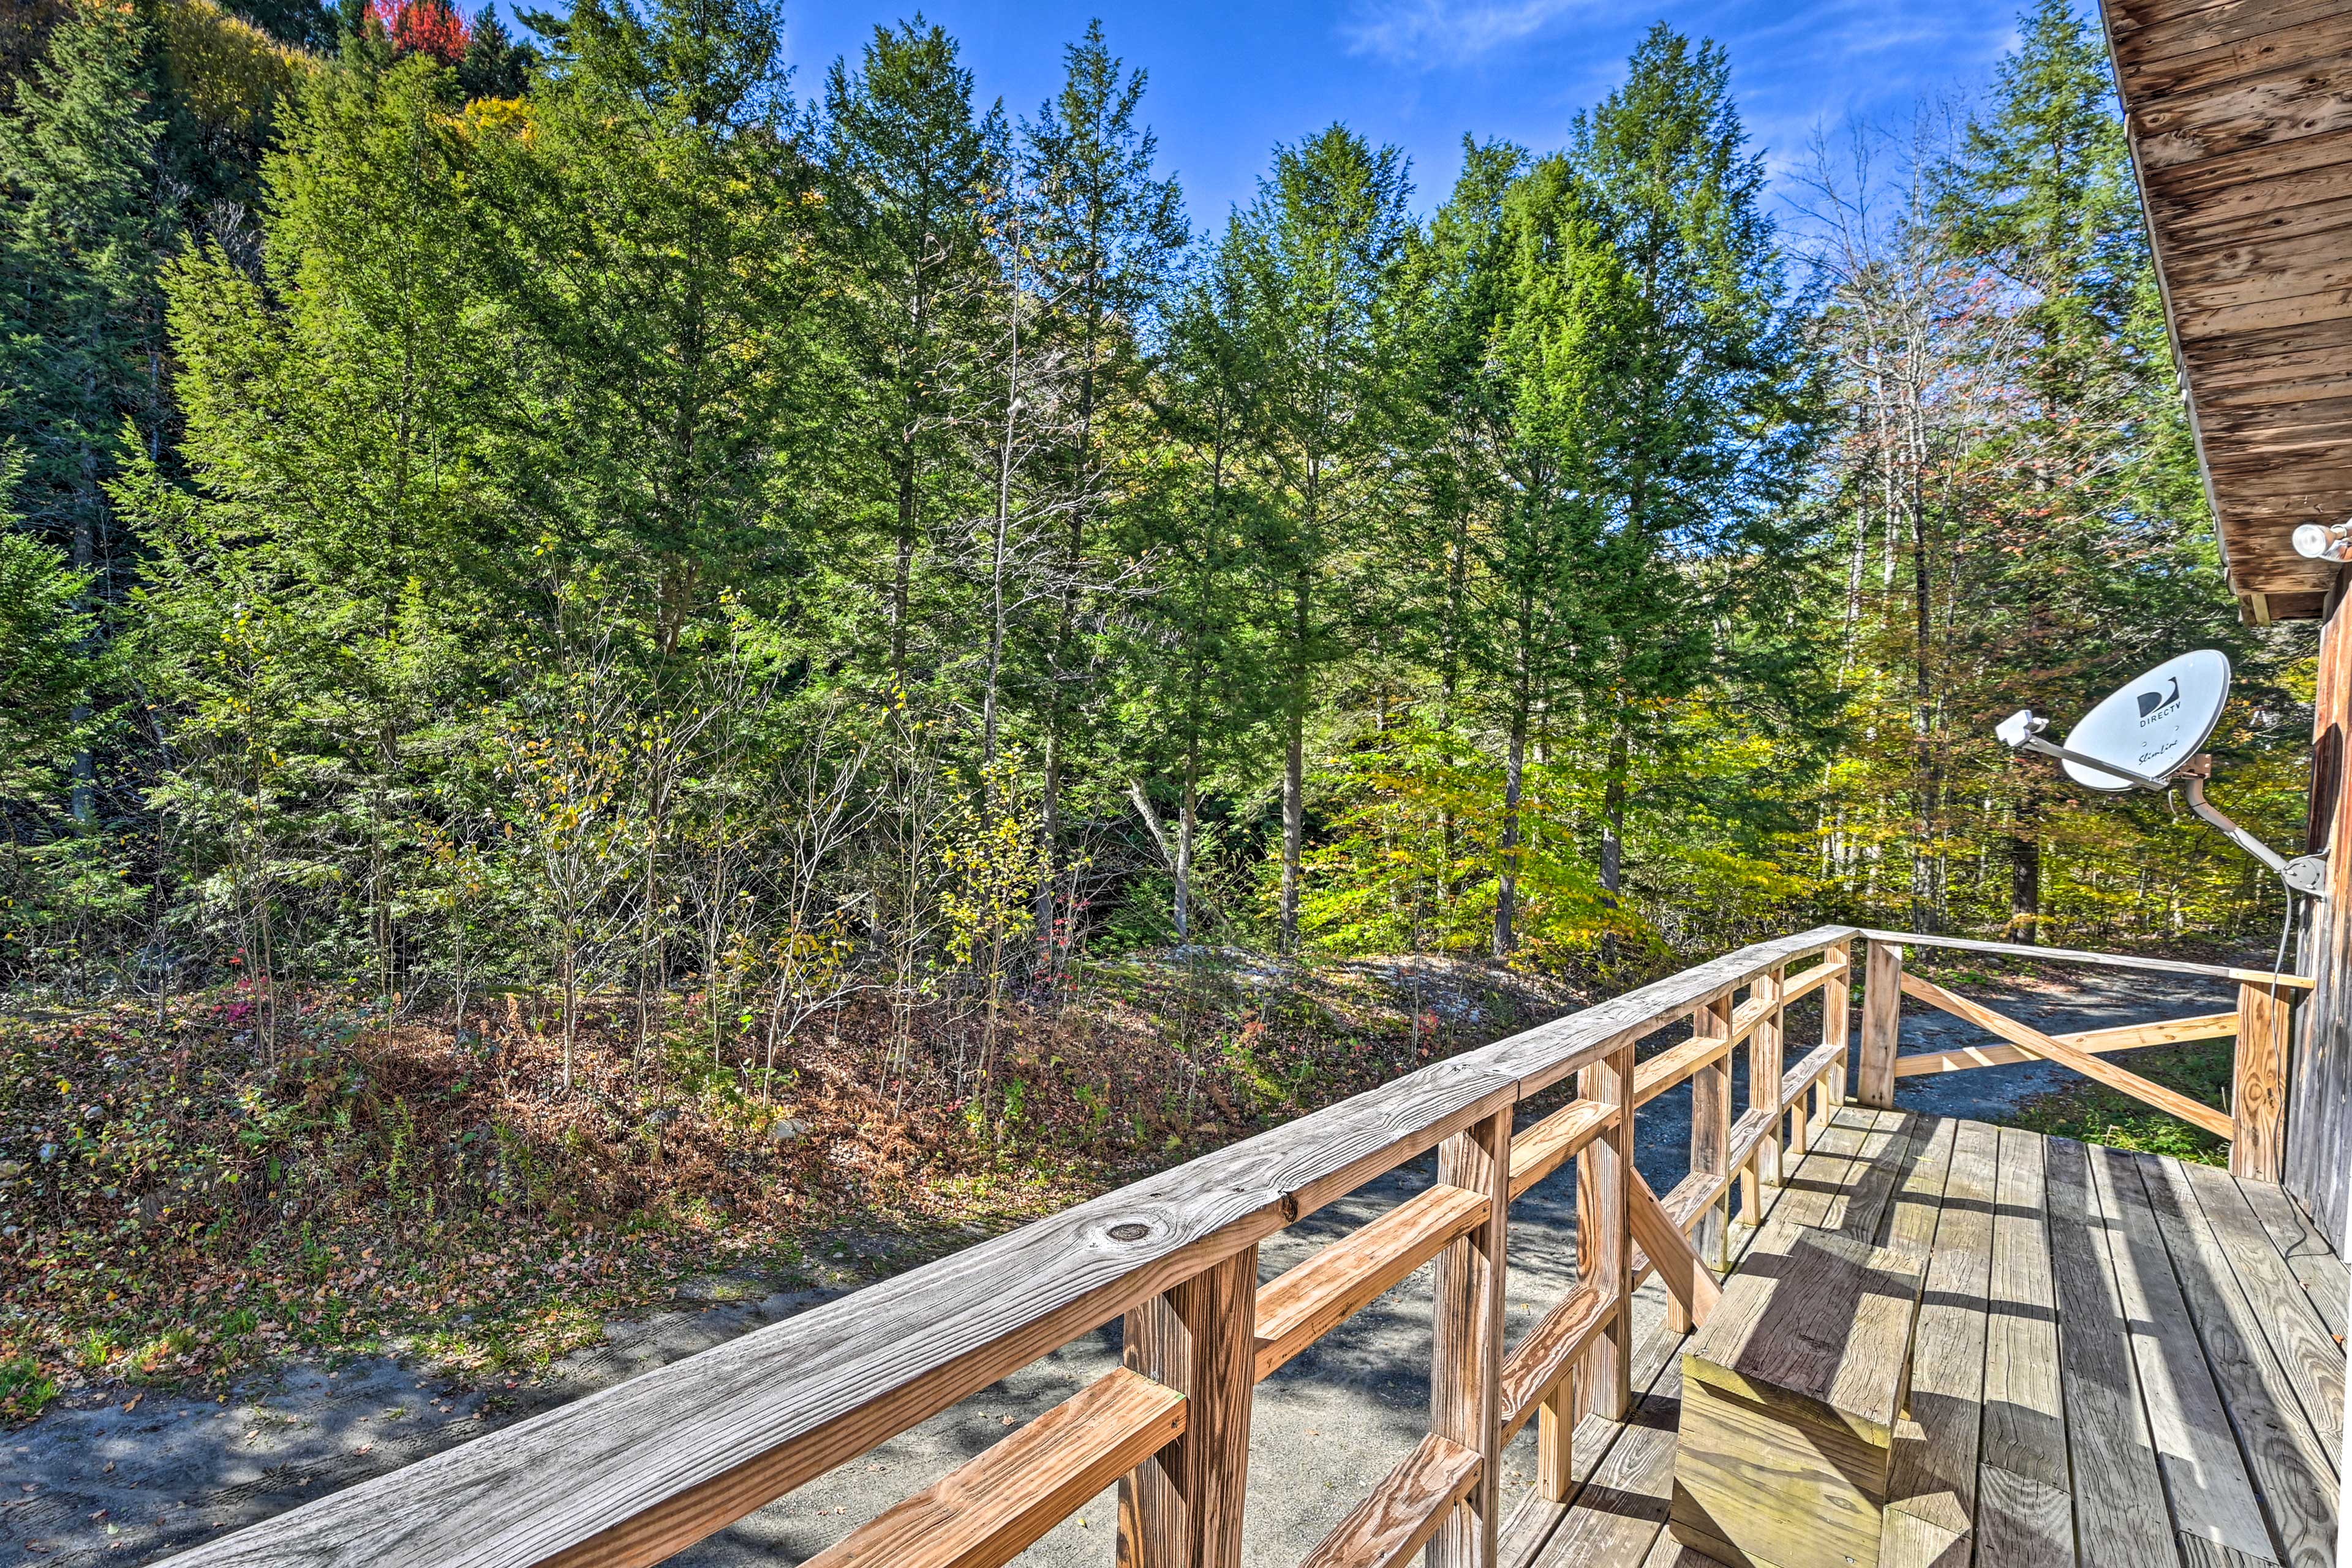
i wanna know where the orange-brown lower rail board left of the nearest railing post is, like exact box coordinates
[809,1368,1188,1568]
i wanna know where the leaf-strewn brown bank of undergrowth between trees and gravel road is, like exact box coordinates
[0,962,1564,1420]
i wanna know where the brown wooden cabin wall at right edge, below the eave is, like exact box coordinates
[2286,592,2352,1253]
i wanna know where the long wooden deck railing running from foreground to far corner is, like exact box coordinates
[174,926,2314,1568]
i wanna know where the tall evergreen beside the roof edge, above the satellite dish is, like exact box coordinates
[1915,0,2239,940]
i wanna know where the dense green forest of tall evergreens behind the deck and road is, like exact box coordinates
[0,0,2312,1394]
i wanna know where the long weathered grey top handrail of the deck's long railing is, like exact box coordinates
[156,926,1853,1568]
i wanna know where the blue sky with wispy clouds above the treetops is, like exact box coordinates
[757,0,2016,228]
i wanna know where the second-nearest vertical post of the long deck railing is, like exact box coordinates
[1430,1105,1510,1568]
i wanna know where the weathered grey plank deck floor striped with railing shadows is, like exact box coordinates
[1501,1105,2347,1568]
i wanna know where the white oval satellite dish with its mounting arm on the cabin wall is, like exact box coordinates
[1992,649,2329,898]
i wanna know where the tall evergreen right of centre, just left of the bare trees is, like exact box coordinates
[1574,23,1815,944]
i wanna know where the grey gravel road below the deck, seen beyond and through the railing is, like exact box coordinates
[0,971,2230,1568]
